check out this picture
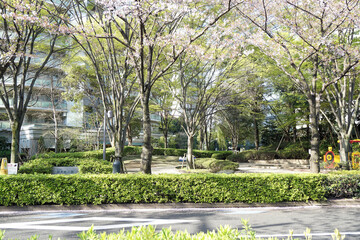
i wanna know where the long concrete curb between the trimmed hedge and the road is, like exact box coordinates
[0,199,360,213]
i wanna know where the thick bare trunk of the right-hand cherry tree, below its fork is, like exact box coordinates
[308,95,320,173]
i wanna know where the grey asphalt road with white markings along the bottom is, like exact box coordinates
[0,205,360,239]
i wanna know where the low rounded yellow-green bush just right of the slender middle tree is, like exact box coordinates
[195,158,239,173]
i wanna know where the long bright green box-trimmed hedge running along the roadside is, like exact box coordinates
[0,174,328,206]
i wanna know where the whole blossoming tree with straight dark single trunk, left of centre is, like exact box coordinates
[91,0,237,174]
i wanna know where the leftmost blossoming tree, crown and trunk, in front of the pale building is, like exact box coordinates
[0,0,68,163]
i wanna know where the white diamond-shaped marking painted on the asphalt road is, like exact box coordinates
[0,217,198,232]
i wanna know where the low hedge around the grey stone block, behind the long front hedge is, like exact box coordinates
[19,157,112,174]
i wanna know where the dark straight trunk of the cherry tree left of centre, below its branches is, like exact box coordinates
[140,96,153,174]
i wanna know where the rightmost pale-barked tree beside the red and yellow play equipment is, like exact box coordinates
[321,26,360,169]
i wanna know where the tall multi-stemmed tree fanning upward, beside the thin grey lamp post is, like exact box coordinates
[67,1,140,173]
